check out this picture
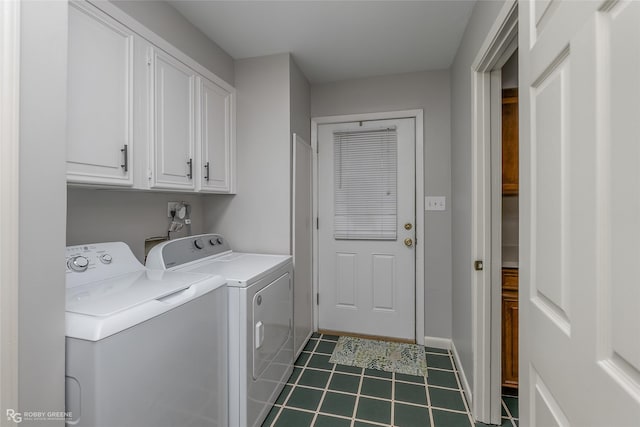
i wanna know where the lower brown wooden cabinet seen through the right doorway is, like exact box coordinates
[502,268,518,388]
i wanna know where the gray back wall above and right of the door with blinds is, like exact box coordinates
[311,70,451,338]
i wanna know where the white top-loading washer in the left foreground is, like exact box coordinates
[66,242,228,427]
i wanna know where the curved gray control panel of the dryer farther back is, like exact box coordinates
[147,234,231,270]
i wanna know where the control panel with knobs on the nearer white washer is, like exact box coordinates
[65,242,144,288]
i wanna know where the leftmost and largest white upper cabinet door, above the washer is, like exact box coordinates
[67,2,134,186]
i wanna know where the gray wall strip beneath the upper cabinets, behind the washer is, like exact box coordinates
[67,188,205,262]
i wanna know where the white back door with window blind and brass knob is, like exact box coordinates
[318,119,415,340]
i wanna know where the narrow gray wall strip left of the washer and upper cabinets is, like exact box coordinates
[18,2,67,426]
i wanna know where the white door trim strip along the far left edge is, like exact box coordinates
[0,1,20,414]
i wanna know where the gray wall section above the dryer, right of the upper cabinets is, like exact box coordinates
[204,54,291,254]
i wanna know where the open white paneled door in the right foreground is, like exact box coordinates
[519,1,640,427]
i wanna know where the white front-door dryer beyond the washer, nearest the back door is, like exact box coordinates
[147,234,293,427]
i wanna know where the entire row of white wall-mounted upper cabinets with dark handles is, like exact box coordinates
[67,1,235,193]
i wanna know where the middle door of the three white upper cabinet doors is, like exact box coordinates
[151,50,196,190]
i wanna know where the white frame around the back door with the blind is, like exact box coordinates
[311,109,425,345]
